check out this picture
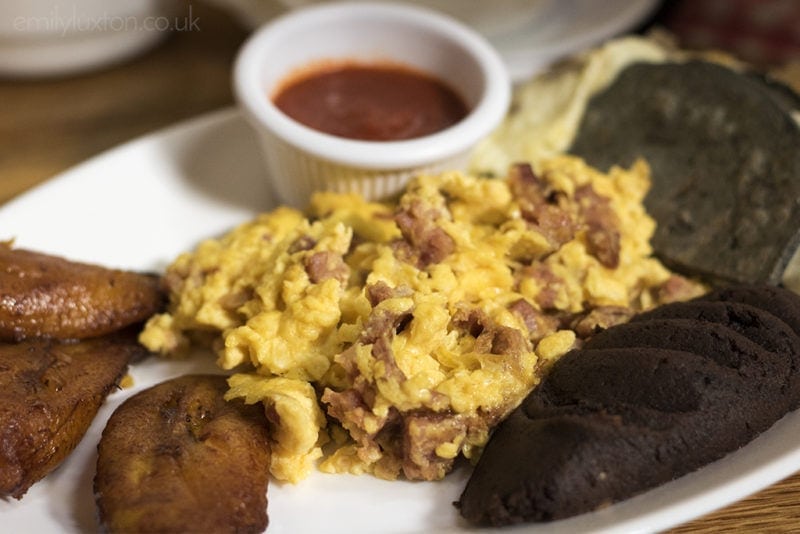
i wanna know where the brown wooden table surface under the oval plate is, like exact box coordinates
[0,4,800,533]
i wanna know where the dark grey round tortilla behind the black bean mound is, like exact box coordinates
[569,61,800,284]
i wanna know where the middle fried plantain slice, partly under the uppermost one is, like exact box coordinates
[0,334,146,499]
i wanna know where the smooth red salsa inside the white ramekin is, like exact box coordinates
[273,64,468,141]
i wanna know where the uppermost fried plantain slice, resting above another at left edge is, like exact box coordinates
[0,242,165,341]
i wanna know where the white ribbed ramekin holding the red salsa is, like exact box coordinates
[233,2,511,207]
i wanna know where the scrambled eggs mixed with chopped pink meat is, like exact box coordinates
[141,156,691,482]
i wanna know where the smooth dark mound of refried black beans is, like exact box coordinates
[456,286,800,526]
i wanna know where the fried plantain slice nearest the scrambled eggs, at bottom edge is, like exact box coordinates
[94,375,270,533]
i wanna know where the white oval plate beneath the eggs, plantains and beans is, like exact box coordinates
[0,110,800,534]
